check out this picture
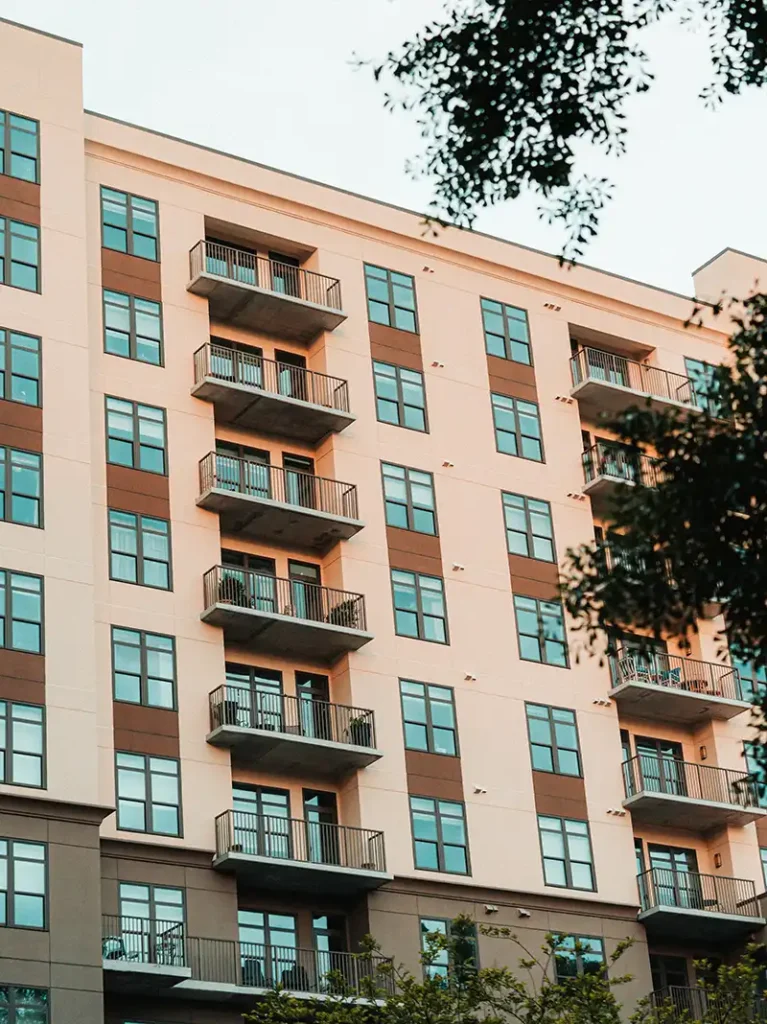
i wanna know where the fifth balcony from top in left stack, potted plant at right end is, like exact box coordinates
[208,684,382,778]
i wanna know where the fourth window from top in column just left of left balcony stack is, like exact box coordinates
[110,509,171,590]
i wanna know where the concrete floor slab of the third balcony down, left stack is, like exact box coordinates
[197,487,365,554]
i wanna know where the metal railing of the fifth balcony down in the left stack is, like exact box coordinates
[210,683,376,748]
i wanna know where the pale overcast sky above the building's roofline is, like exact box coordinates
[0,0,767,293]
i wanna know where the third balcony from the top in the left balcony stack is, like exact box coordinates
[197,452,365,553]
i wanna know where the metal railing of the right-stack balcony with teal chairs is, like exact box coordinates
[612,647,743,700]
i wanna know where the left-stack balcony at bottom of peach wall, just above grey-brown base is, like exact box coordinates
[213,811,392,895]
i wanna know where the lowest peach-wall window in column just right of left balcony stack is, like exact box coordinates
[411,797,469,874]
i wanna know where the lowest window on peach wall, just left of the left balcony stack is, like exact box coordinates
[115,752,181,836]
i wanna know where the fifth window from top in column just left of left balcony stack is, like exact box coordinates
[112,626,176,708]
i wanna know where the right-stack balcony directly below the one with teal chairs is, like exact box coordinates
[623,754,767,831]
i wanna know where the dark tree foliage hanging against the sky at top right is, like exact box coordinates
[374,0,767,257]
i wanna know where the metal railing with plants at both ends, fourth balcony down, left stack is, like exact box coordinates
[203,565,366,630]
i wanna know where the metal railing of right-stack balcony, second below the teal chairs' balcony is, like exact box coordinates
[637,867,761,918]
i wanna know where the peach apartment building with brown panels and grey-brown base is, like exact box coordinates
[0,22,767,1024]
